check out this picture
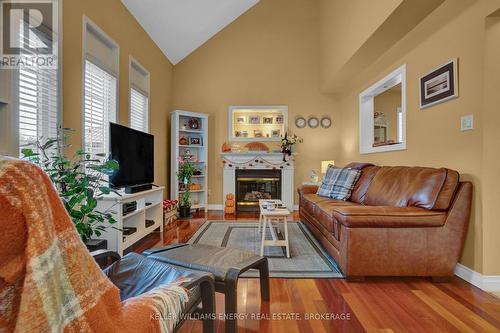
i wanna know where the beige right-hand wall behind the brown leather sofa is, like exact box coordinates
[338,1,500,274]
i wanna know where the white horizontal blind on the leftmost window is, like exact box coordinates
[17,22,59,154]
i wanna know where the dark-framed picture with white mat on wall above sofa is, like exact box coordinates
[420,59,458,109]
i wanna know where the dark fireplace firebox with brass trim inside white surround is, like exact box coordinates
[235,169,281,212]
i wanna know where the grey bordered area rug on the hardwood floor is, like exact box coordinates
[188,221,343,279]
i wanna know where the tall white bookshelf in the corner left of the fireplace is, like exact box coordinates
[170,110,208,211]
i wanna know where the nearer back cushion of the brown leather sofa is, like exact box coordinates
[364,167,447,209]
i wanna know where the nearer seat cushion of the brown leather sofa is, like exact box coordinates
[333,206,446,228]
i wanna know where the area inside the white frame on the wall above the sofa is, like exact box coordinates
[373,83,403,147]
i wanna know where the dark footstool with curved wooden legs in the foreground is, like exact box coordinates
[143,244,269,333]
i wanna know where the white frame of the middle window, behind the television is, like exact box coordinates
[80,15,120,158]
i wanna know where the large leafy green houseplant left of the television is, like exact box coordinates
[21,129,119,243]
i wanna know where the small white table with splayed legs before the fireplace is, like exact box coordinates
[259,199,290,258]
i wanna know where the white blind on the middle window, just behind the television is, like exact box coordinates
[84,60,116,156]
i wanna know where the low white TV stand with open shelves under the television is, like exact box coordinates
[97,187,164,256]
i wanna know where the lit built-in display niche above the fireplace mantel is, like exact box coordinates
[228,105,288,141]
